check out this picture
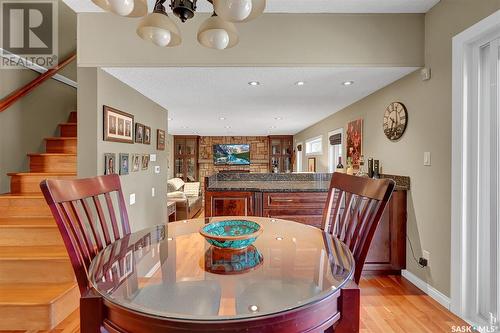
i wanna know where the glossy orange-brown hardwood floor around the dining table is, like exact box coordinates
[0,276,467,333]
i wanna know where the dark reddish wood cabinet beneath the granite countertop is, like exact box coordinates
[205,191,406,274]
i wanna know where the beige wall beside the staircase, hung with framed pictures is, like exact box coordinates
[78,68,168,231]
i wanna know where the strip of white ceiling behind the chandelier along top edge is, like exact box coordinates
[63,0,439,13]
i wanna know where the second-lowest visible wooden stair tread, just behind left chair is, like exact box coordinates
[0,245,69,261]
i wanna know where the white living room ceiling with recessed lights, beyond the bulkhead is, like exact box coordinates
[104,67,417,135]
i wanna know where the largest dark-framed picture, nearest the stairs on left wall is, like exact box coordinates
[103,105,134,143]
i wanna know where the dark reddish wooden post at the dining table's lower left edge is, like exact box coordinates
[80,290,103,333]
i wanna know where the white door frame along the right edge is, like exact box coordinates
[450,10,500,325]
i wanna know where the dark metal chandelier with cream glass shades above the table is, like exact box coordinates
[92,0,266,50]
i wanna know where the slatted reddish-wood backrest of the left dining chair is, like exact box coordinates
[40,175,130,295]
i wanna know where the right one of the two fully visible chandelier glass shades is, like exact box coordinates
[198,15,240,50]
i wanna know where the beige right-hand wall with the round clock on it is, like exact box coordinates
[295,0,500,295]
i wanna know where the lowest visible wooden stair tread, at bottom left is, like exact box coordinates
[0,282,77,304]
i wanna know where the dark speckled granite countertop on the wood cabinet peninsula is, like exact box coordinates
[208,174,410,192]
